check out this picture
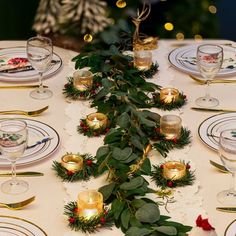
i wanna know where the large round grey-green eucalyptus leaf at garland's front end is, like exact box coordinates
[135,203,160,224]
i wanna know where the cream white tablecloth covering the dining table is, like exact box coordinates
[0,40,236,236]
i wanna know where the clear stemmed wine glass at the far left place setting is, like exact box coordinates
[26,36,53,99]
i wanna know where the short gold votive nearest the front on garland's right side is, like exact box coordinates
[163,161,186,180]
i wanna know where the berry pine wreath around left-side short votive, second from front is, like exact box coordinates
[52,153,97,182]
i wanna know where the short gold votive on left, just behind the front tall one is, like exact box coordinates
[61,154,83,172]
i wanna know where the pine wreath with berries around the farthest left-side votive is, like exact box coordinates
[63,76,102,100]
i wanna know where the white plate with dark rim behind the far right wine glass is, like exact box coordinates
[168,44,236,77]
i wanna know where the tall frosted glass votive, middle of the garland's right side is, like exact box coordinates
[160,115,182,140]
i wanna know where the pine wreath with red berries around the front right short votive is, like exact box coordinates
[152,162,195,189]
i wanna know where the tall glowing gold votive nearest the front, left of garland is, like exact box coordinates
[77,190,103,219]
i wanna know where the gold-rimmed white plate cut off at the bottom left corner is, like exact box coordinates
[0,215,47,236]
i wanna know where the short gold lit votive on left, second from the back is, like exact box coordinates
[86,112,108,129]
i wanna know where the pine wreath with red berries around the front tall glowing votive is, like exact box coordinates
[64,202,113,233]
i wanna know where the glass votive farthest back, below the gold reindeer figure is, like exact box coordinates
[134,50,152,70]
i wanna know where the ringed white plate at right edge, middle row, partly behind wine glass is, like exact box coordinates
[198,112,236,151]
